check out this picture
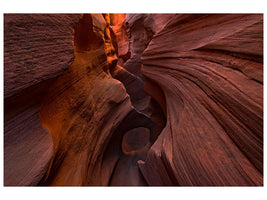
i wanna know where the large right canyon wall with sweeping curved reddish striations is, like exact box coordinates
[140,14,263,186]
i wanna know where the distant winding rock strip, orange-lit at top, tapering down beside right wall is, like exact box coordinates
[111,14,170,126]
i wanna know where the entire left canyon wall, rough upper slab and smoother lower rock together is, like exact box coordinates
[4,14,80,185]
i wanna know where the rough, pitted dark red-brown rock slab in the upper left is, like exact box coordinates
[4,14,80,98]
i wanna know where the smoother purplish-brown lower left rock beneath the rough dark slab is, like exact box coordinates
[4,81,53,186]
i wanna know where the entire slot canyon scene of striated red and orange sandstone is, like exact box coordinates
[4,14,263,186]
